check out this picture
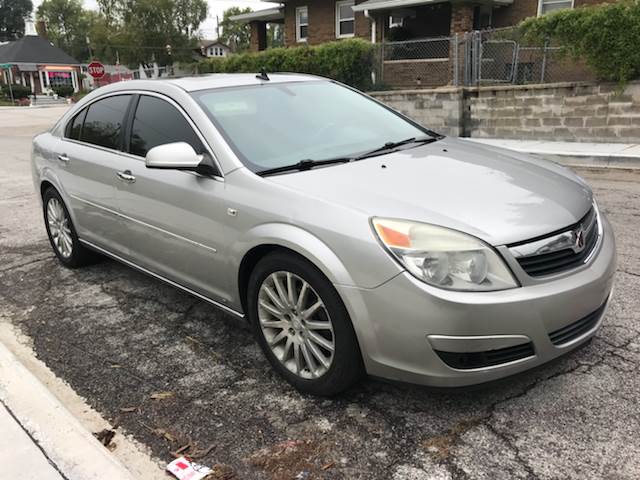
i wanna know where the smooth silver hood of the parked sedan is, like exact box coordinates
[267,138,593,245]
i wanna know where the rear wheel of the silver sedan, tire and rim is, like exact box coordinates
[42,187,97,268]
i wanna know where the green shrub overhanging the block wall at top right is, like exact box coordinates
[520,0,640,84]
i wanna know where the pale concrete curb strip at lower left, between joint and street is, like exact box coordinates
[0,336,141,480]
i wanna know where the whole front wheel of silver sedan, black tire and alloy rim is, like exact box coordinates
[247,252,364,396]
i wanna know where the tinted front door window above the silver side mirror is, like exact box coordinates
[129,95,205,157]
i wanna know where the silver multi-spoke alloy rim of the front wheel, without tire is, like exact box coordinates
[258,271,335,379]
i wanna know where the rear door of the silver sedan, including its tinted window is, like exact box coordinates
[57,94,133,254]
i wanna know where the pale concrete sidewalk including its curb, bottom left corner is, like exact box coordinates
[0,330,164,480]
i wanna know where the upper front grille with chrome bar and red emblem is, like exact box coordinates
[509,208,598,277]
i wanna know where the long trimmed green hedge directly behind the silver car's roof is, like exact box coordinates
[191,38,373,90]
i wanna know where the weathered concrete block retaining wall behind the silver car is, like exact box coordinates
[373,82,640,143]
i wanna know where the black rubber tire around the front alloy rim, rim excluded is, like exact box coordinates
[247,252,364,396]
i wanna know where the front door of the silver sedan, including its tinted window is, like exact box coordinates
[117,94,228,302]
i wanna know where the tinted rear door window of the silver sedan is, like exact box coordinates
[80,95,131,150]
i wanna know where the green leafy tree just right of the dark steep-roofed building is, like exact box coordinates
[36,0,89,61]
